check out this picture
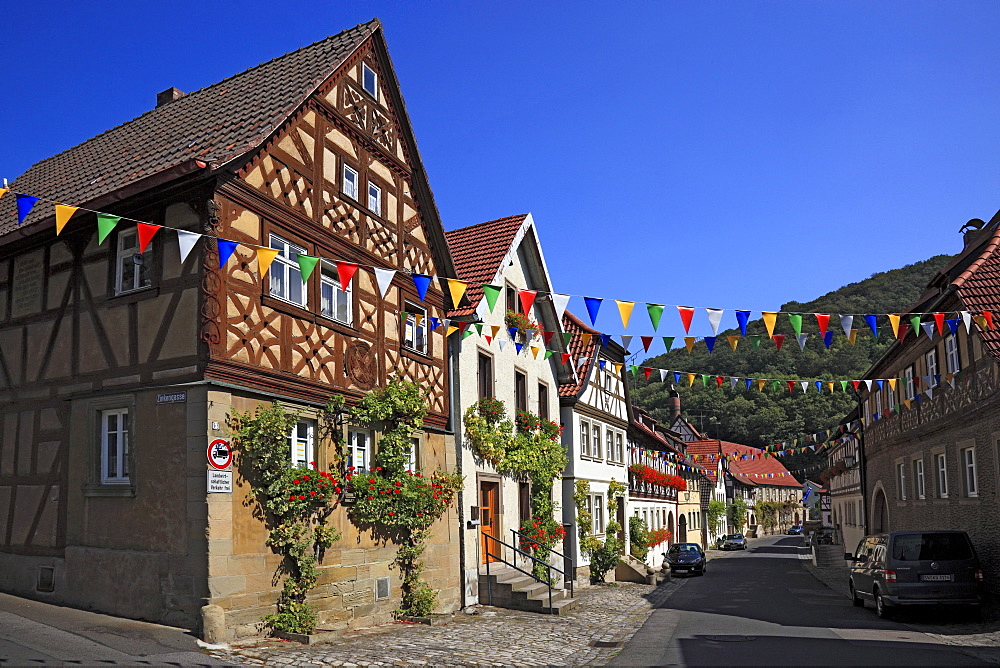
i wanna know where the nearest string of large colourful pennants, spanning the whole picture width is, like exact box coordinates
[7,188,993,336]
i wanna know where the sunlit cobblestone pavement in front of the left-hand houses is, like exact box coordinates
[204,579,685,666]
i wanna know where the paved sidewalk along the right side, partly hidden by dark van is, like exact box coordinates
[800,561,1000,664]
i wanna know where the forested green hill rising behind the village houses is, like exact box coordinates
[632,255,952,478]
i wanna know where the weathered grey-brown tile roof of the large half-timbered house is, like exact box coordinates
[0,19,381,236]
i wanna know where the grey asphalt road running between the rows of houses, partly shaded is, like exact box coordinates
[611,536,989,666]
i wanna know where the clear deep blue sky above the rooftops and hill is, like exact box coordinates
[0,0,1000,334]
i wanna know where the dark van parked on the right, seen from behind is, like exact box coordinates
[844,531,984,617]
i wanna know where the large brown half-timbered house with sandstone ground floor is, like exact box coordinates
[0,20,460,639]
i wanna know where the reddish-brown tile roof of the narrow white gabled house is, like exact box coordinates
[445,213,528,318]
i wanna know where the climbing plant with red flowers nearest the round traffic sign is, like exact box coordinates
[231,403,343,633]
